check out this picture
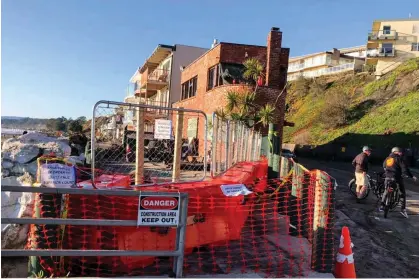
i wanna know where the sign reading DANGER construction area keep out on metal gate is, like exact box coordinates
[137,194,179,227]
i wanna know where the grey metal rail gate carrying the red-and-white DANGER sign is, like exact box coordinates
[1,185,188,277]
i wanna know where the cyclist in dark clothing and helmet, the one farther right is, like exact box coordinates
[380,147,417,218]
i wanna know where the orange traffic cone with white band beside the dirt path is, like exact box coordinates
[335,227,356,278]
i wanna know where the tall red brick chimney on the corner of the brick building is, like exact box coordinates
[265,27,283,89]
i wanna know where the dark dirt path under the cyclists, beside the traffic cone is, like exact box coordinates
[300,158,419,277]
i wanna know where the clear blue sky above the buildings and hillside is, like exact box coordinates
[1,0,419,118]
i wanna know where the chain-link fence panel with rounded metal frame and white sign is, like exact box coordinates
[90,101,207,185]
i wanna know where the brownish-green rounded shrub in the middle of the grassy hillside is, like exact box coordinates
[320,90,351,128]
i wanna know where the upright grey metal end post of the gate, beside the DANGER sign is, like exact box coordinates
[173,196,189,278]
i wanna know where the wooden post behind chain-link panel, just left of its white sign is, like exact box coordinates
[135,107,144,185]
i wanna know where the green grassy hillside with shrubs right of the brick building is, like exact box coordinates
[284,59,419,148]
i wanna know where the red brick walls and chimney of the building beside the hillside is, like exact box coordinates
[173,30,289,158]
